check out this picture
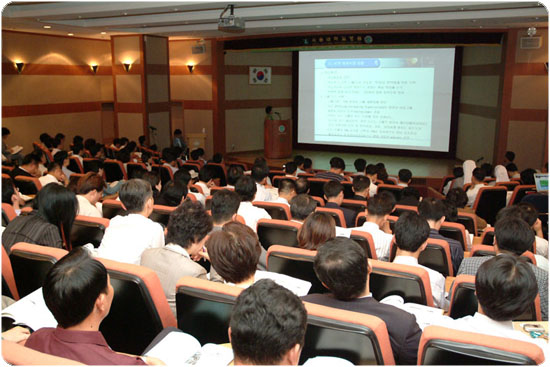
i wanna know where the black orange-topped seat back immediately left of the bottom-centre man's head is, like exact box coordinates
[176,277,239,344]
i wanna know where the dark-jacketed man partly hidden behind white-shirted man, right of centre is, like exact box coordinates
[418,198,464,274]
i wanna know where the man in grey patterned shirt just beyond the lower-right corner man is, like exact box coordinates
[457,217,548,320]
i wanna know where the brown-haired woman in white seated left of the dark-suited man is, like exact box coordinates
[206,222,311,296]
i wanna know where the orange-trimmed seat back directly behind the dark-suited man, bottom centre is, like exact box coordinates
[299,302,395,365]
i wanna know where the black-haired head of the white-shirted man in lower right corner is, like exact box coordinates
[475,254,538,321]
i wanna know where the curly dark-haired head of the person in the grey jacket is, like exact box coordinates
[166,200,212,255]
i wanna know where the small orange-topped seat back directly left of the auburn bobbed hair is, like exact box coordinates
[257,219,302,251]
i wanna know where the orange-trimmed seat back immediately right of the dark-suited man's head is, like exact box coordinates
[369,260,434,307]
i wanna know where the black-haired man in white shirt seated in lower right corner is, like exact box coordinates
[434,254,549,361]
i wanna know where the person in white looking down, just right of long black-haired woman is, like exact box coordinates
[76,172,105,218]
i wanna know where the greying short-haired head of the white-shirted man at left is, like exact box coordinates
[119,178,154,217]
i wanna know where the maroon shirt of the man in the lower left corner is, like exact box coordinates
[25,327,145,365]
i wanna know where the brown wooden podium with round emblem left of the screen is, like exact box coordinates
[264,118,292,158]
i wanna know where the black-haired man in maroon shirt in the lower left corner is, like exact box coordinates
[25,248,160,365]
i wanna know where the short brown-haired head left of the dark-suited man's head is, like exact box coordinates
[206,222,262,284]
